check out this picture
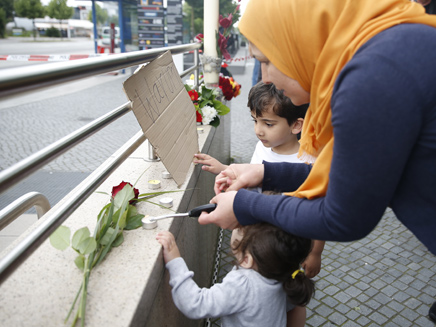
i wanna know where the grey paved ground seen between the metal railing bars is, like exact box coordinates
[0,74,140,213]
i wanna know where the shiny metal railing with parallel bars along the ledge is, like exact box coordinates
[0,43,201,283]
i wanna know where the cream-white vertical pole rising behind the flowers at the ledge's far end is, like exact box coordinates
[203,0,219,86]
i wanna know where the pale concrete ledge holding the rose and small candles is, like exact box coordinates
[0,115,230,327]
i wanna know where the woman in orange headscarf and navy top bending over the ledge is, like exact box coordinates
[199,0,436,320]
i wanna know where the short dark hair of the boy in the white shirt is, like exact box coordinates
[247,81,309,126]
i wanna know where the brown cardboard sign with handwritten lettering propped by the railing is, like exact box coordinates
[123,51,199,186]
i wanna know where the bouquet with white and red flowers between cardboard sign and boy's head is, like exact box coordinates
[185,84,230,127]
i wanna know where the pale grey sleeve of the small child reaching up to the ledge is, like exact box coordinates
[166,258,250,319]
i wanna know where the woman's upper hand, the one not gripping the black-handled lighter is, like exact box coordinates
[214,164,264,194]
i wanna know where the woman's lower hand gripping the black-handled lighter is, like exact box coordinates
[198,191,240,230]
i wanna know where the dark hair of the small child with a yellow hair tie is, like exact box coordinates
[231,223,315,306]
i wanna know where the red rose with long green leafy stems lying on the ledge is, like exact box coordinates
[50,181,178,326]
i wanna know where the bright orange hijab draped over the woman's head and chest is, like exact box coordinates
[238,0,436,199]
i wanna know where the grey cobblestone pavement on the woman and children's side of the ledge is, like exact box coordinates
[211,50,436,327]
